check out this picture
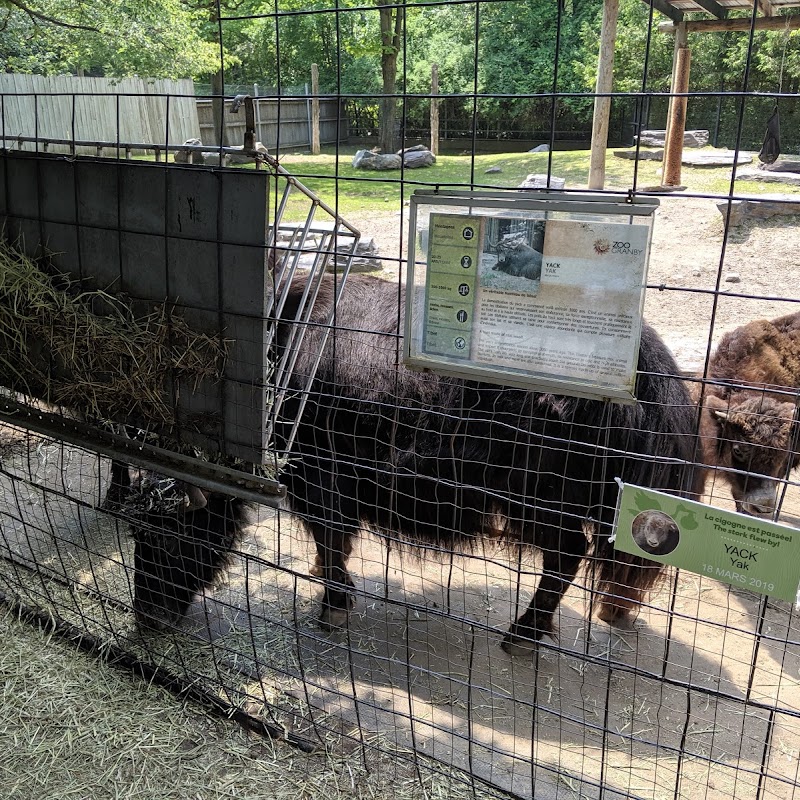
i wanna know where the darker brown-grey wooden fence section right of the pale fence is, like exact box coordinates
[197,97,348,152]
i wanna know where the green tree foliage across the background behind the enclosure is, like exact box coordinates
[0,0,800,147]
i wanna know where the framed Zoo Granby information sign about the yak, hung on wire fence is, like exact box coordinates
[406,193,655,400]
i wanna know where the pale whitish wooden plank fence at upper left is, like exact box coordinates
[0,73,200,155]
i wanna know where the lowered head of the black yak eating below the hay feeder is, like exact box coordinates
[124,473,244,629]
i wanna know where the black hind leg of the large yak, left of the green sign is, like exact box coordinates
[502,526,587,656]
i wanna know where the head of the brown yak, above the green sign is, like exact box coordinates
[702,394,799,517]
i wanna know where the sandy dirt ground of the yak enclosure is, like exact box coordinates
[0,191,800,800]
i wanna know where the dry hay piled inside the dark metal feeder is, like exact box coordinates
[0,240,226,426]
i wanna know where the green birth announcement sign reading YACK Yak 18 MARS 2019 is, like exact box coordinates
[614,484,800,601]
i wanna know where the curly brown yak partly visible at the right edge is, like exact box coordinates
[700,312,800,517]
